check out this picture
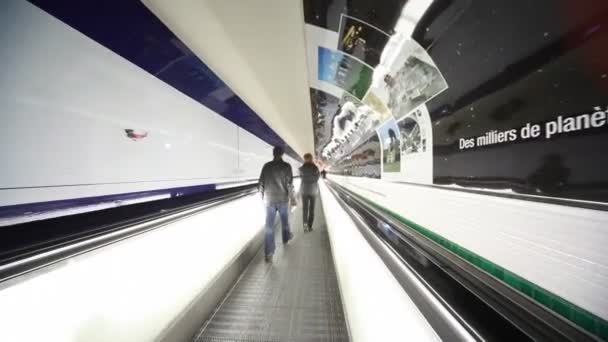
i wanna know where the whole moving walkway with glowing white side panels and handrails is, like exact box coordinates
[0,181,599,341]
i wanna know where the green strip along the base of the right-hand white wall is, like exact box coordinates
[360,192,608,340]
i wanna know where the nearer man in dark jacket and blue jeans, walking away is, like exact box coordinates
[259,146,296,262]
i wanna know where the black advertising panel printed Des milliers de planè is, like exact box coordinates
[426,1,608,202]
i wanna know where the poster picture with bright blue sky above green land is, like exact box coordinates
[318,46,373,100]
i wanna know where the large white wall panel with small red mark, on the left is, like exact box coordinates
[0,0,280,210]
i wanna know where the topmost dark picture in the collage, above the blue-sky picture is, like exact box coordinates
[338,14,390,67]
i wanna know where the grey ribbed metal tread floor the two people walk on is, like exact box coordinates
[195,199,349,342]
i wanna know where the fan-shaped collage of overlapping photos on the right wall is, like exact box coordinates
[306,7,447,178]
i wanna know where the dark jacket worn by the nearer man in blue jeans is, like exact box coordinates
[259,159,293,204]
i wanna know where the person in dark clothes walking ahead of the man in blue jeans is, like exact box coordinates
[300,153,319,232]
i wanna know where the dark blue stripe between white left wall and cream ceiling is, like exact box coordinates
[29,0,300,160]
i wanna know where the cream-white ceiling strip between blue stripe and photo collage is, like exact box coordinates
[142,0,314,155]
